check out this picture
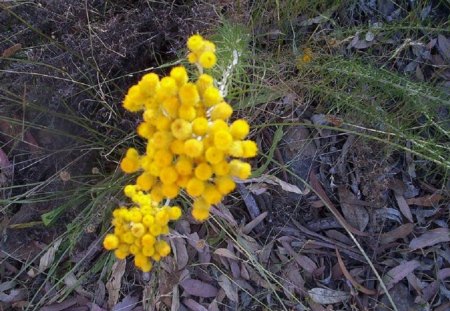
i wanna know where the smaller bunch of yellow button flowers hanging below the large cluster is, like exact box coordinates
[103,205,181,272]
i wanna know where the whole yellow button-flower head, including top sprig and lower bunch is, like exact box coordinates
[104,35,258,271]
